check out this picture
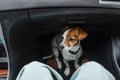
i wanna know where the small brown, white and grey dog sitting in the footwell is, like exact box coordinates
[44,26,88,76]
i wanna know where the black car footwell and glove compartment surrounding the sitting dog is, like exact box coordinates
[0,0,120,80]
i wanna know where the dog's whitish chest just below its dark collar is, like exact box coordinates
[62,49,82,60]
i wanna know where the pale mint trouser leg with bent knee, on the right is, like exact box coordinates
[70,61,115,80]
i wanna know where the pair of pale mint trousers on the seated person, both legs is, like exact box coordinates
[16,61,115,80]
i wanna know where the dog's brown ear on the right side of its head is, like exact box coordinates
[75,27,88,40]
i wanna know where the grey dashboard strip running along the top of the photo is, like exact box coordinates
[0,0,120,11]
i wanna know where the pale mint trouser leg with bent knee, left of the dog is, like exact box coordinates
[16,61,63,80]
